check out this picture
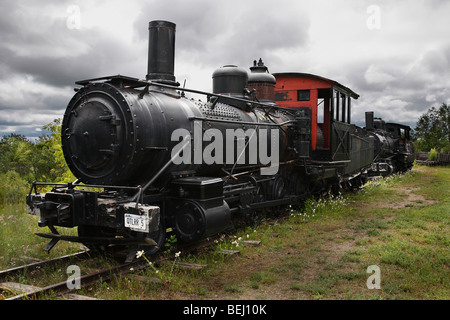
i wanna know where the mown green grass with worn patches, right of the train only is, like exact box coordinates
[157,167,450,299]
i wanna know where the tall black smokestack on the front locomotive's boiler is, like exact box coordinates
[146,20,176,84]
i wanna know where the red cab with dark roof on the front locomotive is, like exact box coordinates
[274,73,373,172]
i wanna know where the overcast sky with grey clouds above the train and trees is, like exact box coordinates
[0,0,450,137]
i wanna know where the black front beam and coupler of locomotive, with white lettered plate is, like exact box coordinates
[27,183,160,251]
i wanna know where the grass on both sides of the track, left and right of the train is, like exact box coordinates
[0,166,450,300]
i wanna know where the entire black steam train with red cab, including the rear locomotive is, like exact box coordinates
[26,21,413,257]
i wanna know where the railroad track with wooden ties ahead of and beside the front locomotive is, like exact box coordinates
[0,238,221,300]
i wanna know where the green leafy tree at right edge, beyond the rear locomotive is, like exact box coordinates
[414,103,450,152]
